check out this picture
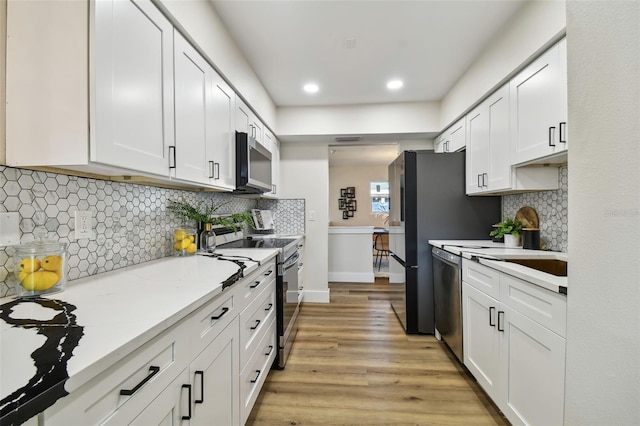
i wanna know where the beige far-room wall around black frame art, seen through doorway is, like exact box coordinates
[329,165,389,227]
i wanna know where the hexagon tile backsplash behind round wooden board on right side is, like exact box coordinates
[502,166,569,252]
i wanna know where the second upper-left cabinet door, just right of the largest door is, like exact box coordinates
[174,32,214,183]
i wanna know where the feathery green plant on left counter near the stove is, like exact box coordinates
[167,201,254,245]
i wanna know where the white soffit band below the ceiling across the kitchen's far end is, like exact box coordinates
[277,102,441,136]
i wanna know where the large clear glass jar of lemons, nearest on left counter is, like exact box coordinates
[15,241,67,297]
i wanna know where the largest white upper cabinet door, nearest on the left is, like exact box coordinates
[90,0,174,176]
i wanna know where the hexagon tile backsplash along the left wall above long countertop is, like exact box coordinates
[0,166,304,297]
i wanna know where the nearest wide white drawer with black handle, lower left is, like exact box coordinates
[45,321,190,426]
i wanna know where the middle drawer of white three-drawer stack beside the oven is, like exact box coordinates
[240,282,276,369]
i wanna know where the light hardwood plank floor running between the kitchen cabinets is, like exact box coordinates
[247,279,509,426]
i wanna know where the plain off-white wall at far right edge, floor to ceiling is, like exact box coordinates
[565,0,640,425]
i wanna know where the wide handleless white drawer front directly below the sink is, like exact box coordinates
[500,274,567,337]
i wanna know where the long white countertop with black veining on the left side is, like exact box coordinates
[0,249,278,422]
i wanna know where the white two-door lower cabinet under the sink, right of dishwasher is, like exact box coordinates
[462,261,566,425]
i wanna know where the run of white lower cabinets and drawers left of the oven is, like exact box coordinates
[41,260,277,426]
